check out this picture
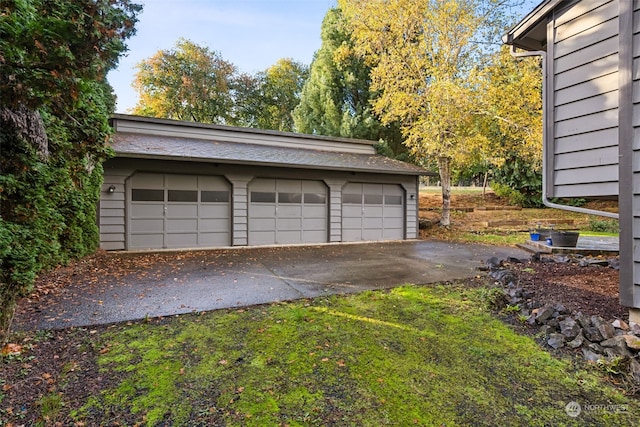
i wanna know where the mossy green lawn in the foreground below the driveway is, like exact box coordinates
[8,285,640,426]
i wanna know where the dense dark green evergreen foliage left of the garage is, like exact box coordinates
[0,0,141,338]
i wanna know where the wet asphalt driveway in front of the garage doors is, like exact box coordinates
[13,241,529,330]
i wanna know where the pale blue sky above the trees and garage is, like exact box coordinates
[107,0,537,113]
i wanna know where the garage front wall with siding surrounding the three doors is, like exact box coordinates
[99,158,418,250]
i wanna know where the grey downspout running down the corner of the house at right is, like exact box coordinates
[510,44,619,219]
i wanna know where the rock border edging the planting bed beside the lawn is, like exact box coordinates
[480,258,640,385]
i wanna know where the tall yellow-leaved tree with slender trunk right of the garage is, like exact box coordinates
[338,0,536,226]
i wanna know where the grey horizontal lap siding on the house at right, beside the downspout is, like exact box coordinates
[551,0,619,197]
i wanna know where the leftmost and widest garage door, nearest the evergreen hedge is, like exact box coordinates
[129,173,231,249]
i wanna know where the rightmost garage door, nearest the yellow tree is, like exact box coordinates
[342,183,404,242]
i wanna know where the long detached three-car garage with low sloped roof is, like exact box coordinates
[99,114,431,250]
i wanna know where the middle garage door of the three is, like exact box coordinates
[249,179,328,245]
